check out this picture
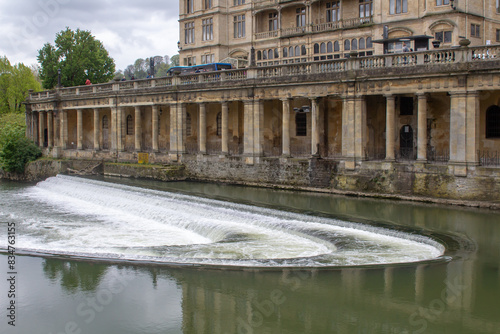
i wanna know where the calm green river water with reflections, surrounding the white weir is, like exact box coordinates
[0,177,500,334]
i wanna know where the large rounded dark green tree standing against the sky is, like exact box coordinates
[38,28,115,89]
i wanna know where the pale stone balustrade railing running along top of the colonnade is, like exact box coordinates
[29,45,500,101]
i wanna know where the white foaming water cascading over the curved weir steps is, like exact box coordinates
[0,175,444,267]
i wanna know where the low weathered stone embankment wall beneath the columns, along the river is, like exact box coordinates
[4,155,500,208]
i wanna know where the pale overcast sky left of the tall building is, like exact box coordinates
[0,0,179,70]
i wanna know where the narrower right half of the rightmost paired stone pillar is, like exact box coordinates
[465,92,480,166]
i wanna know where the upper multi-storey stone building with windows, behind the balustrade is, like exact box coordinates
[179,0,500,66]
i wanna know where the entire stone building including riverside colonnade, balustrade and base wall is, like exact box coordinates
[26,0,500,201]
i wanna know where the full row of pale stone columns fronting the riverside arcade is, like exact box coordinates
[32,91,480,173]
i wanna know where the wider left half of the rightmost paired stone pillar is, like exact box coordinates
[450,92,468,176]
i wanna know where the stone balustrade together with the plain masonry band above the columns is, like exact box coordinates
[27,45,500,104]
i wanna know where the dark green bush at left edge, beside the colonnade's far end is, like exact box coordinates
[0,114,42,173]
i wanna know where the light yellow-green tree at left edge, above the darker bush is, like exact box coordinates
[0,57,42,114]
